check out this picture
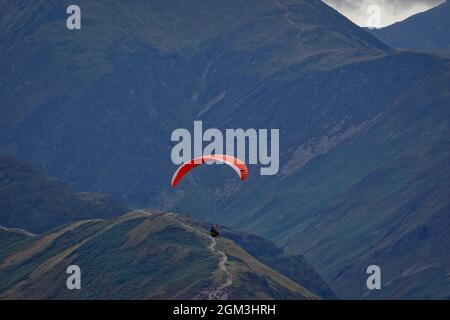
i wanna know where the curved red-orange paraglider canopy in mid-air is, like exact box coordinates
[172,154,248,188]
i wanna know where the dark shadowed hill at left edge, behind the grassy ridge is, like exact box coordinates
[0,156,125,232]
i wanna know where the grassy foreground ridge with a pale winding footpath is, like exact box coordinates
[0,210,332,299]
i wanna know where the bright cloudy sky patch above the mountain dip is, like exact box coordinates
[323,0,445,27]
